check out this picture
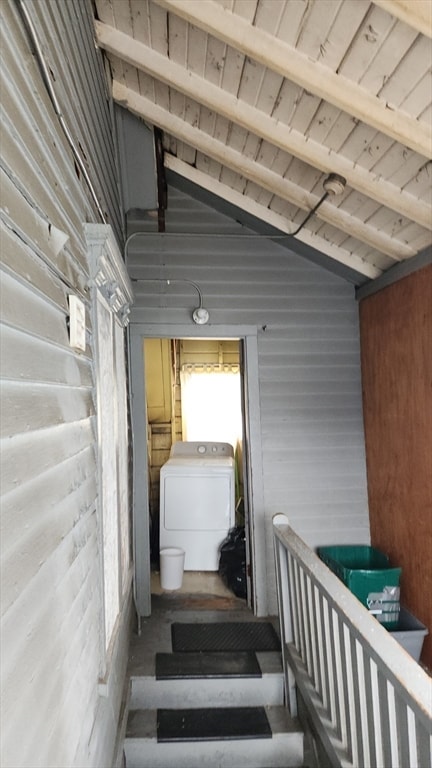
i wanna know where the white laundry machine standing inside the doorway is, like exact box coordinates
[160,442,235,571]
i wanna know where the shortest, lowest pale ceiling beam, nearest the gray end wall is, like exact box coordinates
[164,152,382,279]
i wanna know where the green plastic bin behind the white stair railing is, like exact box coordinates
[317,544,402,629]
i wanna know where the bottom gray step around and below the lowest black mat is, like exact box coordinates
[124,698,303,768]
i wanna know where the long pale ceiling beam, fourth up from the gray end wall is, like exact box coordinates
[154,0,432,158]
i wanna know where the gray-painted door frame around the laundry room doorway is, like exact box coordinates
[129,323,267,620]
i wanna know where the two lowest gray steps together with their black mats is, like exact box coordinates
[124,622,303,768]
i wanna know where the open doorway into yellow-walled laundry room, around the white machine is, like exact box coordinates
[143,338,251,603]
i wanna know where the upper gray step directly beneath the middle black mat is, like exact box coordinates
[130,651,284,709]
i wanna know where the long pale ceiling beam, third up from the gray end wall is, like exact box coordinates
[95,21,432,229]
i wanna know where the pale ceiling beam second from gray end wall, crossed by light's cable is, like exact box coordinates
[112,80,415,261]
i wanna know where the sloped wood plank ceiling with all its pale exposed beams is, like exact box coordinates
[95,0,432,279]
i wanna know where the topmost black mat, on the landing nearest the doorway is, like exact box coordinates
[171,621,280,652]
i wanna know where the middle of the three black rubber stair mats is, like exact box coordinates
[156,651,262,680]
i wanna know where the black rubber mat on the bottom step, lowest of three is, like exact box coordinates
[157,707,272,742]
